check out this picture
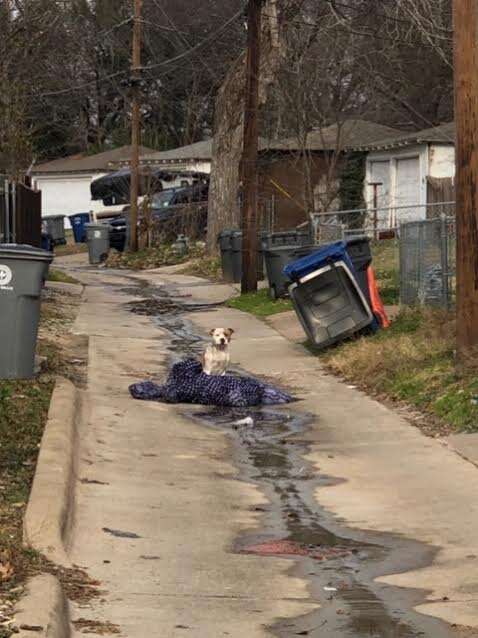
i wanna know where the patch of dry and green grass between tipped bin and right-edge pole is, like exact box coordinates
[319,308,478,436]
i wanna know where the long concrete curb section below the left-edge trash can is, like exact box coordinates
[23,379,81,567]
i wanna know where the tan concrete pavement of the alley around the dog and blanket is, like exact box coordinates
[57,266,478,638]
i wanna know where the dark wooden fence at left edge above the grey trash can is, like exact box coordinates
[0,180,41,248]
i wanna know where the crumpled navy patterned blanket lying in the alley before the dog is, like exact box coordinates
[129,359,293,407]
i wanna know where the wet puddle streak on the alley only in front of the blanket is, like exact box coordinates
[188,408,451,638]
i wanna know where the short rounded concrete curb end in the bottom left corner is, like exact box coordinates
[15,574,72,638]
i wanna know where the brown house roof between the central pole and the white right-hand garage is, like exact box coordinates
[260,120,402,151]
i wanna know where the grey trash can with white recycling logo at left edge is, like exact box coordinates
[0,244,53,379]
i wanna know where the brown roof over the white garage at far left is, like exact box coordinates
[32,146,159,175]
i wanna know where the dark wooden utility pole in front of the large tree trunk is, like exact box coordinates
[240,0,263,293]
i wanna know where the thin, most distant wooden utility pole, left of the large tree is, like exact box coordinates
[129,0,143,252]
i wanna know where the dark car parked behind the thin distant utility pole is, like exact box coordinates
[110,184,209,251]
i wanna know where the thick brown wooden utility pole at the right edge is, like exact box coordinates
[453,0,478,363]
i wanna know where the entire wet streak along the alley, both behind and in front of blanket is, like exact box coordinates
[118,282,454,638]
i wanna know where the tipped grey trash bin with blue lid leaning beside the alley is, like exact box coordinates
[285,242,373,348]
